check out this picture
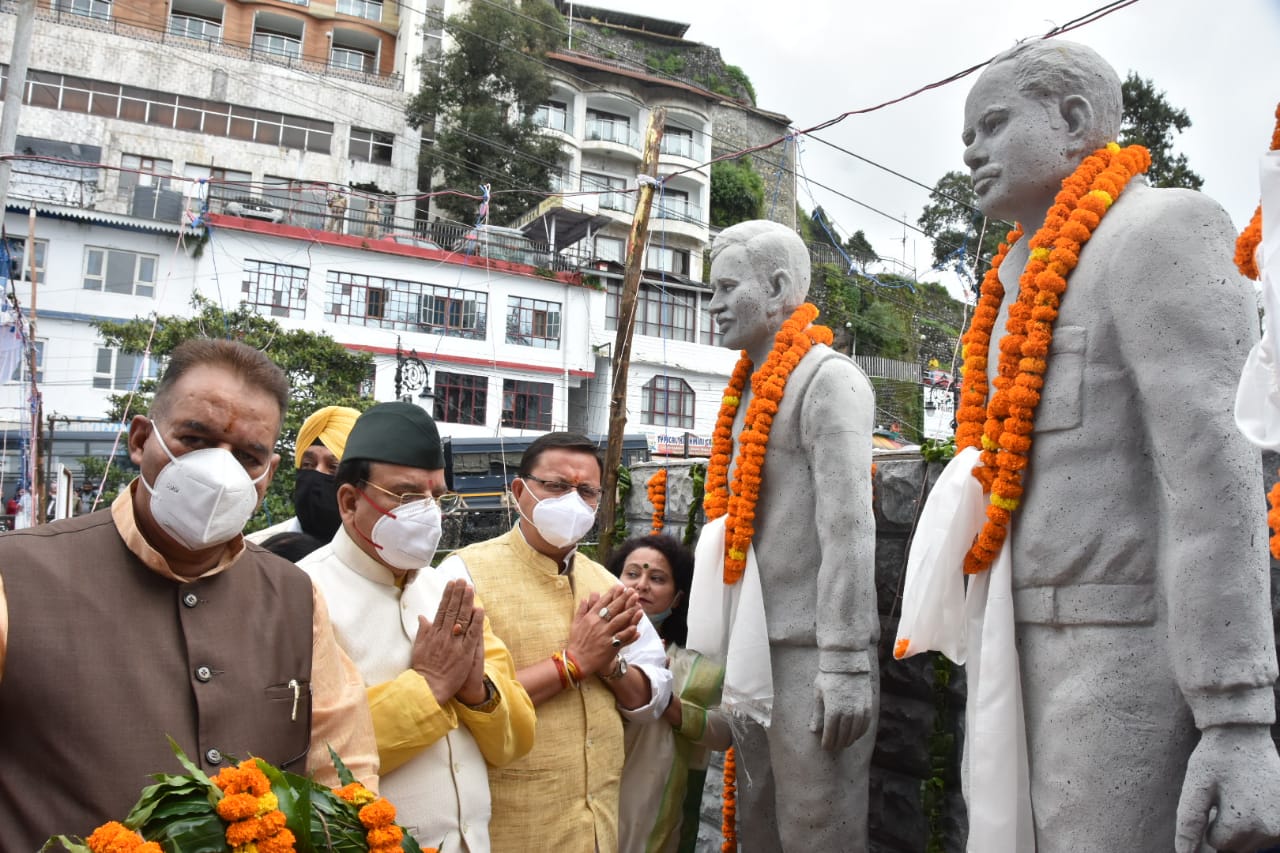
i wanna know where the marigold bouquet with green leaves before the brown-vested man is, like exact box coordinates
[44,738,434,853]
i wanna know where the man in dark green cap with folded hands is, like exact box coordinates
[298,402,534,853]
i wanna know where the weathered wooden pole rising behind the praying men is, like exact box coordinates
[599,106,667,562]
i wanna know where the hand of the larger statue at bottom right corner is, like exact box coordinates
[1174,725,1280,853]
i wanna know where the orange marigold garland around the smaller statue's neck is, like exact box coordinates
[703,302,832,584]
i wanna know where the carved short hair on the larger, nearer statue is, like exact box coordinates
[988,38,1124,149]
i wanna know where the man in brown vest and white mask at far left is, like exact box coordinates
[0,339,378,850]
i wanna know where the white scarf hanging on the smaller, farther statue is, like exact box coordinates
[687,515,773,726]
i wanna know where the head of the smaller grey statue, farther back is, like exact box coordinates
[708,219,809,361]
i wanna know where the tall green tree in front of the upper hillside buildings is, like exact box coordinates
[407,0,567,223]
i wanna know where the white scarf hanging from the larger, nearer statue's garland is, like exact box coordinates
[893,447,1036,853]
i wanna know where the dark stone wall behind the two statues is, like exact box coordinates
[626,453,1280,853]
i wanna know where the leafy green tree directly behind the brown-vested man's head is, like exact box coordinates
[93,296,372,530]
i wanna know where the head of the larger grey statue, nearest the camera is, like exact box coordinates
[963,40,1121,222]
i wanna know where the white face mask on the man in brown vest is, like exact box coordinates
[141,420,271,551]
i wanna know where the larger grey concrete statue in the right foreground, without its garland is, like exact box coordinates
[962,41,1280,853]
